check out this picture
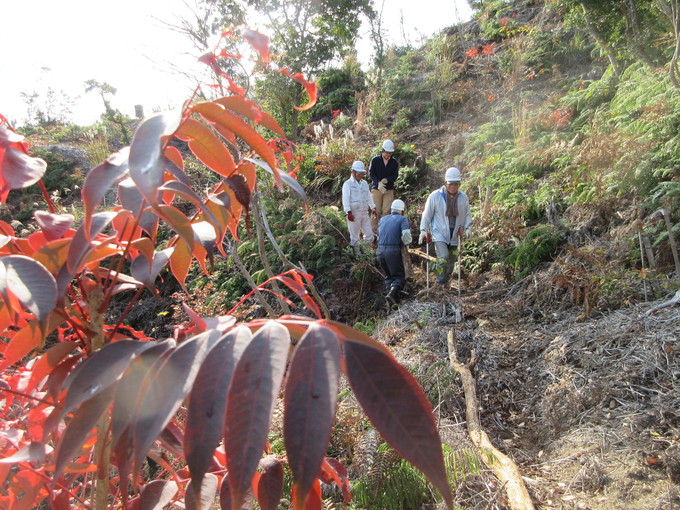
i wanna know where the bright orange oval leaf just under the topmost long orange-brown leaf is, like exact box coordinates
[175,118,236,177]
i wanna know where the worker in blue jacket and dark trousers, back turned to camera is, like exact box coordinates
[376,200,412,305]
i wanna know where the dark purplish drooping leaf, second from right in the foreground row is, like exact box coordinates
[283,324,341,508]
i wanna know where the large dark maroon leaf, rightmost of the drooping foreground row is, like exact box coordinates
[344,338,453,506]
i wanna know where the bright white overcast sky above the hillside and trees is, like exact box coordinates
[0,0,470,126]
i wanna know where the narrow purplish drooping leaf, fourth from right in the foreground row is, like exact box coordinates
[184,326,252,496]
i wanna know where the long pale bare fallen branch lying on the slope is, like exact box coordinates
[447,330,535,510]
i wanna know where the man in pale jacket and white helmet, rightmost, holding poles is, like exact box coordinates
[418,167,472,286]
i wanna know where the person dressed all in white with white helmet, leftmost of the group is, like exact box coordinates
[342,161,375,255]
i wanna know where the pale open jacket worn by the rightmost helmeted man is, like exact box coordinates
[420,186,472,246]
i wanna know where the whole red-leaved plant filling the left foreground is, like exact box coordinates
[0,28,452,510]
